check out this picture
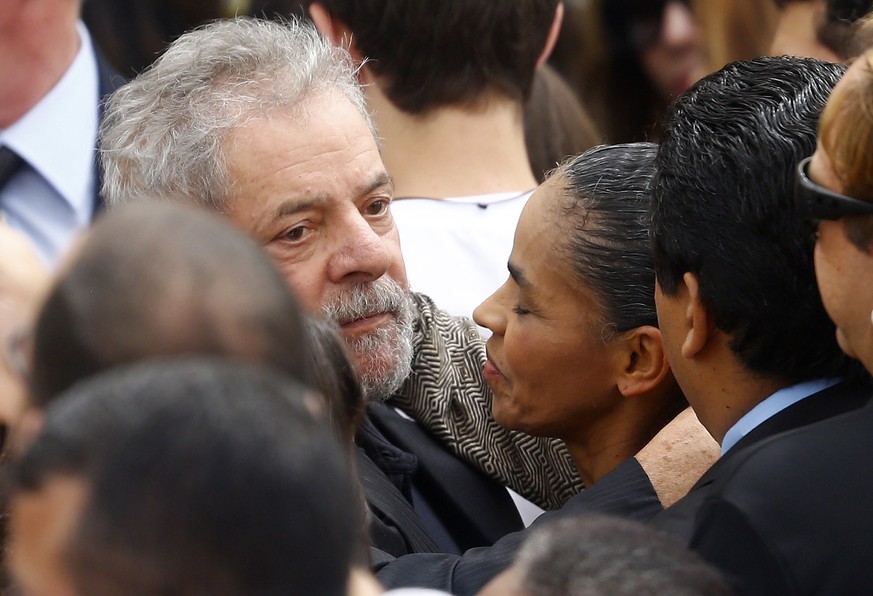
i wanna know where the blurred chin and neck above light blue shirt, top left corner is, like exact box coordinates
[0,2,79,129]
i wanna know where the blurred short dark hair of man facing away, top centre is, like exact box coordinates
[304,0,559,114]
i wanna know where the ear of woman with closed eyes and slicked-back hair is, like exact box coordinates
[618,325,670,397]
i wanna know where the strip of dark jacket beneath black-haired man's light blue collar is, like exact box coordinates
[650,383,869,545]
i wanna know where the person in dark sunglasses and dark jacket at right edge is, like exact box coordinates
[691,39,873,594]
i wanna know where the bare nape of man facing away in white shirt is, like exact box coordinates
[367,85,536,199]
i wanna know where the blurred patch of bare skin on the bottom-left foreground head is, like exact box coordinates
[9,476,87,596]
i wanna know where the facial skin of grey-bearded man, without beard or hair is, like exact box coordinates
[220,95,408,382]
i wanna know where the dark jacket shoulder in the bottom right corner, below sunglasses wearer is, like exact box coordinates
[690,394,873,595]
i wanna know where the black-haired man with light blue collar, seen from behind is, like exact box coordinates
[652,57,869,548]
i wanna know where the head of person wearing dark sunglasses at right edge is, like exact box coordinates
[796,50,873,371]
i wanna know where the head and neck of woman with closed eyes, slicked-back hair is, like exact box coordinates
[474,143,686,486]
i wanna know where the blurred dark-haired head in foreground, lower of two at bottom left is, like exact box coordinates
[8,359,363,596]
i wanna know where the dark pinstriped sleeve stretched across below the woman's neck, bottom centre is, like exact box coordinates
[375,458,662,596]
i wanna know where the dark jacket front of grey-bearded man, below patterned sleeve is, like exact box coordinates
[357,404,524,560]
